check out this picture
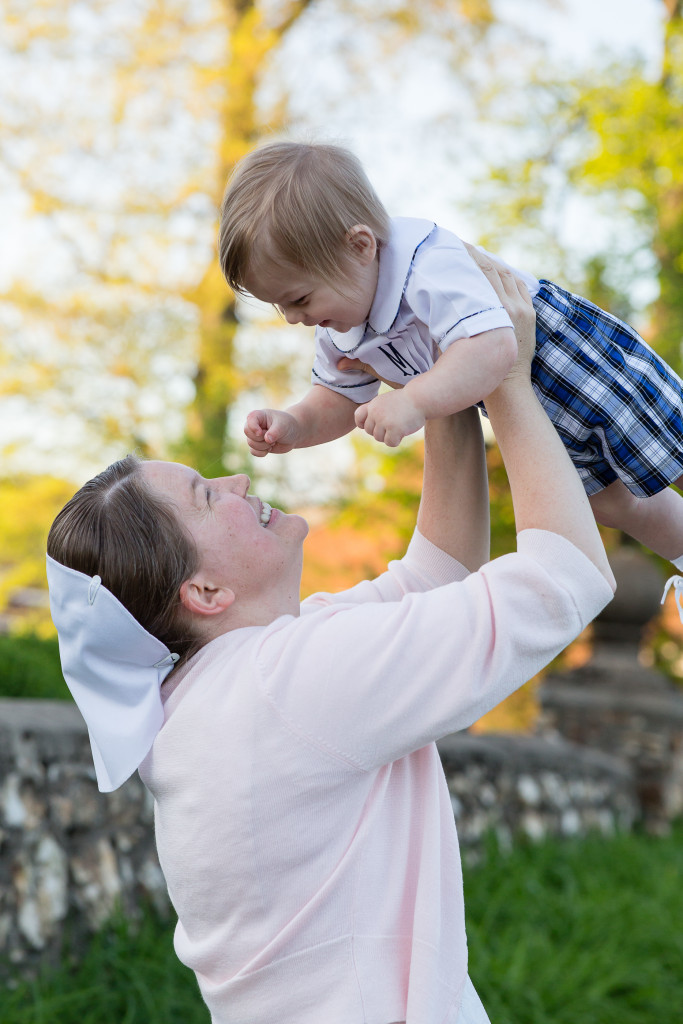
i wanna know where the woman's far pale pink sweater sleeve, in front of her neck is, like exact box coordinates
[301,529,469,614]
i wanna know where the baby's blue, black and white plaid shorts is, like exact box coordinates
[531,281,683,498]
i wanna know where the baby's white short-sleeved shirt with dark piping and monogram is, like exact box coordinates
[311,217,540,404]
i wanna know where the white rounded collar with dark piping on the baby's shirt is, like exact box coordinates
[328,217,436,352]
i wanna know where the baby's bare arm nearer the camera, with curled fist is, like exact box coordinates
[355,327,517,447]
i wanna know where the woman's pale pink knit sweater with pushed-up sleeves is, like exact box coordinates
[140,530,611,1024]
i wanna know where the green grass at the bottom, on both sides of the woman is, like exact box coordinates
[1,826,683,1024]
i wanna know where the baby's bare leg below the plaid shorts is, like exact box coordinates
[590,478,683,561]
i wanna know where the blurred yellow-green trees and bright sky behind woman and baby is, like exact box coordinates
[0,0,683,708]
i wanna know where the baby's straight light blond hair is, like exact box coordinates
[218,142,389,292]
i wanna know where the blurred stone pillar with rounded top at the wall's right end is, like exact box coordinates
[540,547,683,833]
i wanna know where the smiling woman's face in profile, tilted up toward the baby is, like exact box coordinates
[141,462,308,604]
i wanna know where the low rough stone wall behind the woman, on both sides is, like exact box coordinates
[0,700,637,977]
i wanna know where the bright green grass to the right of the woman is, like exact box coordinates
[465,826,683,1024]
